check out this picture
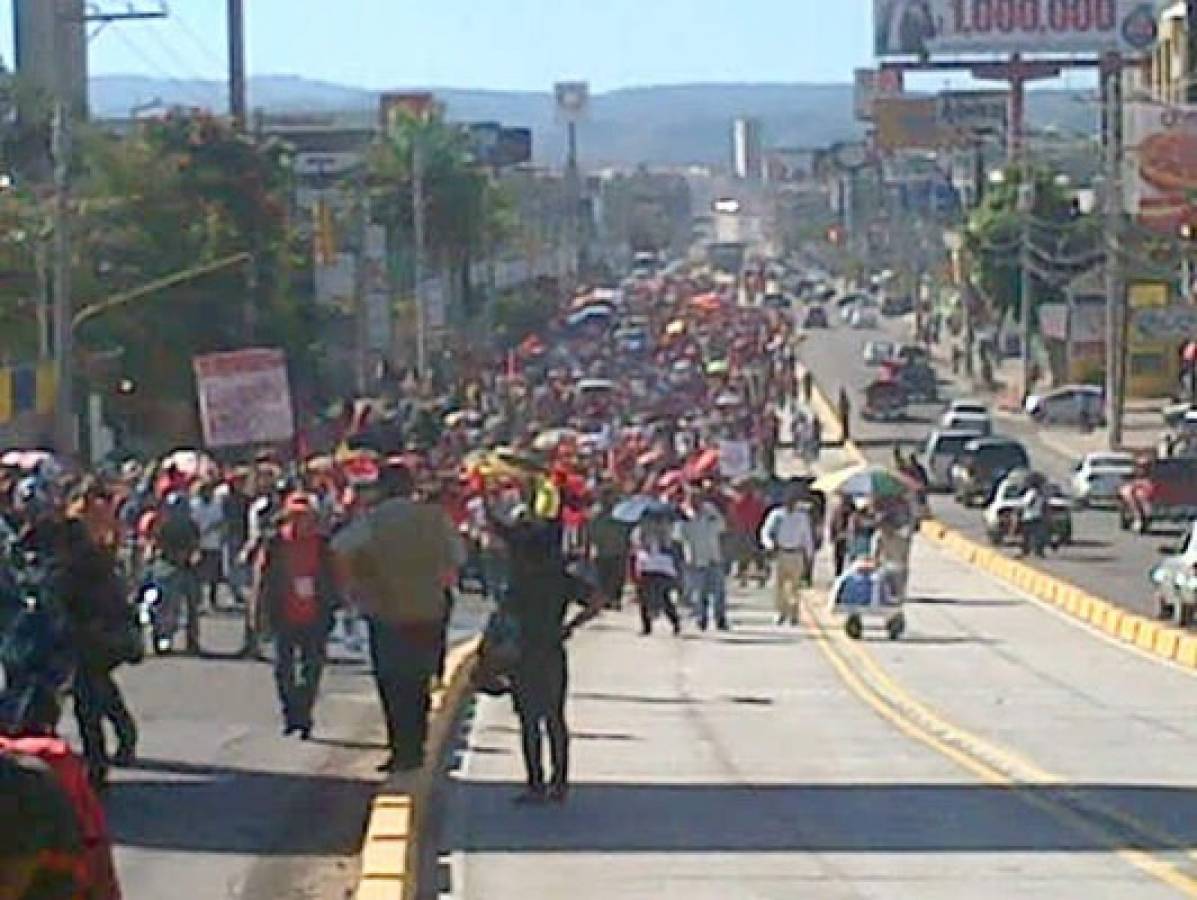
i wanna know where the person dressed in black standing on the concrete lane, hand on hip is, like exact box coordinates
[498,516,604,803]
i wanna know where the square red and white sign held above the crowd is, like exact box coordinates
[193,349,294,446]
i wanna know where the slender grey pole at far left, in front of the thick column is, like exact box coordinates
[50,101,78,456]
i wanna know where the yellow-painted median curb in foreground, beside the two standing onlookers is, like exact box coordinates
[354,638,481,900]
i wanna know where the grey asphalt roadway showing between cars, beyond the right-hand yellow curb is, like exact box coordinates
[801,321,1179,615]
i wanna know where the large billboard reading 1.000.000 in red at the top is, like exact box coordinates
[873,0,1156,57]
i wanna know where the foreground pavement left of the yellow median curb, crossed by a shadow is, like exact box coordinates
[85,604,479,900]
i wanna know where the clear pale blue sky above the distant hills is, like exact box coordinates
[0,0,871,91]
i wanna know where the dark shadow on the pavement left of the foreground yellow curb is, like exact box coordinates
[111,759,377,856]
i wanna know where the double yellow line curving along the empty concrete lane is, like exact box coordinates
[806,602,1197,896]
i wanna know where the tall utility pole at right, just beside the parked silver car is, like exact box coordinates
[1101,54,1126,450]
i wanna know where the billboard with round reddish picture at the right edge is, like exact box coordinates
[1124,102,1197,235]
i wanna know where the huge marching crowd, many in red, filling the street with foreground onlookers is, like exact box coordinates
[0,259,909,896]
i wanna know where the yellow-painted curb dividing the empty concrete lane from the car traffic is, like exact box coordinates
[812,361,1197,670]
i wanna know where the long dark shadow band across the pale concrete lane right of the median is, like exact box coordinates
[445,780,1197,853]
